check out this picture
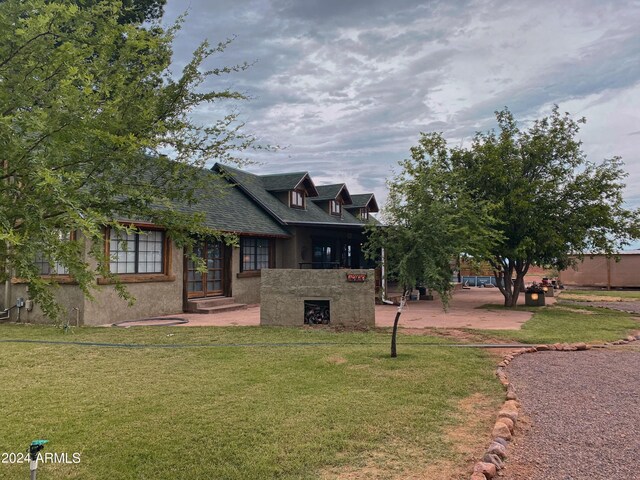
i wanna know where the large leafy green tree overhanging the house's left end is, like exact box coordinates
[0,0,254,317]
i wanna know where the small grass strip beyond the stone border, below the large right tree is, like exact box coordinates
[481,304,640,344]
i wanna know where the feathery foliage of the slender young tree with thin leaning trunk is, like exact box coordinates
[366,133,499,307]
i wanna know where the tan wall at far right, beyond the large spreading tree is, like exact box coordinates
[560,254,640,288]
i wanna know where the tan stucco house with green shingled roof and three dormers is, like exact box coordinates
[11,164,378,325]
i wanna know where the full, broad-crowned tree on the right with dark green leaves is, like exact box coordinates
[456,106,640,306]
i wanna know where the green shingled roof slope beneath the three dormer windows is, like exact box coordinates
[213,163,371,227]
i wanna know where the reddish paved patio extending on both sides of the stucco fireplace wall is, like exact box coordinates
[121,287,555,330]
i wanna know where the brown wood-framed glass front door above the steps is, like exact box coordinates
[187,241,225,298]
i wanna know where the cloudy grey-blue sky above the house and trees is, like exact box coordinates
[165,0,640,236]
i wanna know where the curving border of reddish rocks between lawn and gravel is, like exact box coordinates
[470,334,640,480]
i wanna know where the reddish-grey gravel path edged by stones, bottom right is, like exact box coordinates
[502,347,640,480]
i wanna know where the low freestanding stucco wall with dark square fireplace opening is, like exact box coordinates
[260,269,375,327]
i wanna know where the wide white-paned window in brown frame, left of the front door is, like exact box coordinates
[109,230,165,273]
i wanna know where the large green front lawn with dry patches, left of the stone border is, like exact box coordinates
[0,325,502,479]
